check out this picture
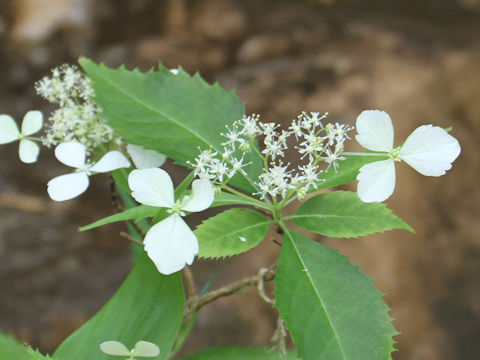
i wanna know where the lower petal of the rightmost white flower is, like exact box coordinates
[357,159,395,202]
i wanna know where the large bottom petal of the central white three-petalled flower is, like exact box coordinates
[144,214,198,275]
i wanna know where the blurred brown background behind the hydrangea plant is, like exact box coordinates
[0,0,480,360]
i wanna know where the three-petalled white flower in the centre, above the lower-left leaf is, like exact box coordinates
[128,168,215,275]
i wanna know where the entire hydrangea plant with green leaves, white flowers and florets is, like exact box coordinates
[0,59,460,360]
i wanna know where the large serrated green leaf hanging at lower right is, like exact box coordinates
[275,229,398,360]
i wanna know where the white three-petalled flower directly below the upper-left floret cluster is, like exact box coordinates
[47,142,130,201]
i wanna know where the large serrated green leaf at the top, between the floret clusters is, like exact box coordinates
[80,58,262,192]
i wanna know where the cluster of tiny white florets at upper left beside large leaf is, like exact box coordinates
[35,65,113,150]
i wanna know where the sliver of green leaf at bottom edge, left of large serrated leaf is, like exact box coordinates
[183,346,297,360]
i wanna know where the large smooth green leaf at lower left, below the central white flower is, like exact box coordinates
[54,252,185,360]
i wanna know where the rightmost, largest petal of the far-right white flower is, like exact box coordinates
[400,125,460,176]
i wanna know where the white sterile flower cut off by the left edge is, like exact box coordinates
[0,110,43,164]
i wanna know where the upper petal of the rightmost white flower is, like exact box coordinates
[355,110,393,152]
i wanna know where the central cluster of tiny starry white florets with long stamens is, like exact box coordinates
[190,112,352,199]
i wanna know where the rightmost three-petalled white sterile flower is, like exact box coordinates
[355,110,460,202]
